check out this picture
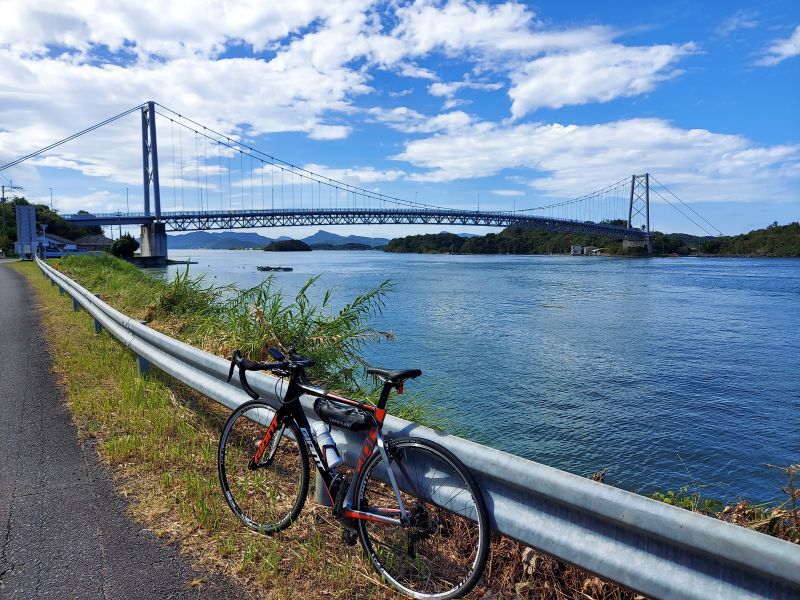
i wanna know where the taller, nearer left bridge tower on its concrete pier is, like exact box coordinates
[141,100,167,262]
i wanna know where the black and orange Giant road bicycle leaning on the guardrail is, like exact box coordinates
[217,349,489,599]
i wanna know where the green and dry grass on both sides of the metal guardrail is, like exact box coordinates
[15,257,800,600]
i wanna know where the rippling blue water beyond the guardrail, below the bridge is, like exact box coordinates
[155,250,800,500]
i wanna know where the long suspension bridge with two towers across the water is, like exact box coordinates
[0,101,720,258]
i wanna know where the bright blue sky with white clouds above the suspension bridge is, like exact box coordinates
[0,0,800,237]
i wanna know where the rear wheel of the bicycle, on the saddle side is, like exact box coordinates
[355,438,489,599]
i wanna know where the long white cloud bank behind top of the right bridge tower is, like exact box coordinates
[395,119,800,201]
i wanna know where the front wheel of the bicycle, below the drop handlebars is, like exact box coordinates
[217,401,309,533]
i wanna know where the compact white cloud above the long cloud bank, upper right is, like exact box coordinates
[509,44,695,118]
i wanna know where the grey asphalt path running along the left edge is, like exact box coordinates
[0,264,243,600]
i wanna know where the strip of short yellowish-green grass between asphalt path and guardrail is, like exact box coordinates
[14,263,394,599]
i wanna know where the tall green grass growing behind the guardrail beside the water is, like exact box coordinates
[56,255,396,398]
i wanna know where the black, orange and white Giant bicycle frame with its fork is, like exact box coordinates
[250,377,409,525]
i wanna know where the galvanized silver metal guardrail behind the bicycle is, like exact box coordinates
[37,260,800,600]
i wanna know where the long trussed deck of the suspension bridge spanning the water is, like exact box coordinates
[65,208,650,241]
